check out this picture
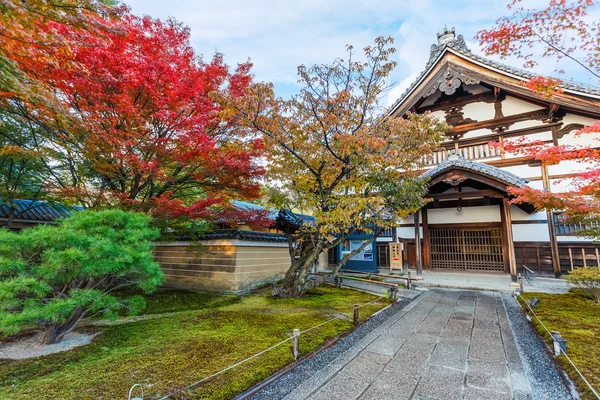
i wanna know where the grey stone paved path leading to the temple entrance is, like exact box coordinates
[285,289,570,400]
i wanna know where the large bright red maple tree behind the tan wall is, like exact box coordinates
[2,2,266,228]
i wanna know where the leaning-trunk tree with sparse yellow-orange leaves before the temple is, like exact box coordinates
[223,38,446,297]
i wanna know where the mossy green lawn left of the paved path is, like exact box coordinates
[0,287,388,399]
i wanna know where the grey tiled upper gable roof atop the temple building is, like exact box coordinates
[390,28,600,113]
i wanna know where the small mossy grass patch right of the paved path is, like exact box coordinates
[519,291,600,399]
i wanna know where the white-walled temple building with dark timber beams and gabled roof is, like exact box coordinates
[360,28,600,281]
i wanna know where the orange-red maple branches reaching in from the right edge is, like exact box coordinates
[477,0,600,238]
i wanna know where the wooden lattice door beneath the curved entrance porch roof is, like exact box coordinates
[429,228,504,272]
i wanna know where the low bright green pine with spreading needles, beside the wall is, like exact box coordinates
[0,210,164,344]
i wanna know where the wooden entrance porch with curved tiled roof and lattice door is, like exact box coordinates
[405,154,560,282]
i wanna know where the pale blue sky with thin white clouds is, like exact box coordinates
[125,0,597,105]
